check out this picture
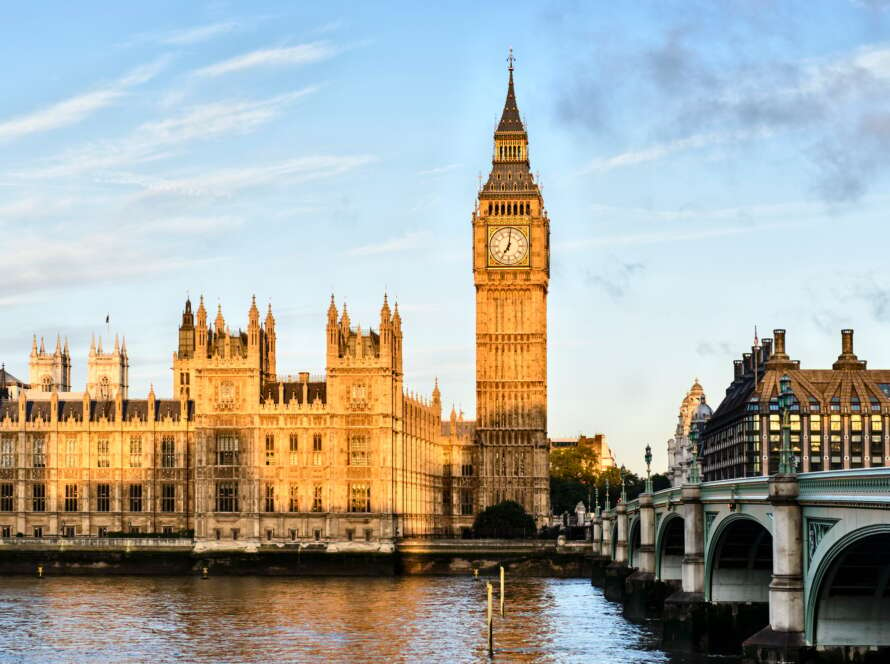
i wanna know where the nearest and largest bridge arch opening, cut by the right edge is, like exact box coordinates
[806,523,890,647]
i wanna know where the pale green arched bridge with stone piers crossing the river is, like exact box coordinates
[593,468,890,662]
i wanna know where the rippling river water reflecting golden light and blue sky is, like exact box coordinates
[0,577,736,664]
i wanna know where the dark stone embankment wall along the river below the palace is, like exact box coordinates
[0,538,591,578]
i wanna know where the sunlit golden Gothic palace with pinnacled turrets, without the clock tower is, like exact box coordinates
[0,298,475,548]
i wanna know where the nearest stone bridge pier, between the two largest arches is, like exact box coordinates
[743,475,805,664]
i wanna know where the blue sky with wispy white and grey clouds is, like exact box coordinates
[0,0,890,471]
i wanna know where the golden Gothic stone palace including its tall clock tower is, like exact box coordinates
[0,60,550,547]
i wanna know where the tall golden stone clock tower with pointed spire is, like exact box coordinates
[473,52,550,524]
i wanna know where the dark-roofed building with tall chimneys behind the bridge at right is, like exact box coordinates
[702,330,890,480]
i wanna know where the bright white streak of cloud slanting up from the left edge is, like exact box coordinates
[0,58,167,141]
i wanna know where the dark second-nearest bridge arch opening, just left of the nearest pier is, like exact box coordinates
[704,514,773,604]
